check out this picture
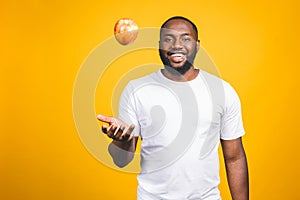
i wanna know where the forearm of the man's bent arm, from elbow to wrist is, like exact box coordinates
[108,137,137,167]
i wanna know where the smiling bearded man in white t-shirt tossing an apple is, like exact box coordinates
[97,16,249,200]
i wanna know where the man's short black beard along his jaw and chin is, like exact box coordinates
[159,47,197,76]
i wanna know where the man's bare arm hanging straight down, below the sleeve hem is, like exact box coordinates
[221,138,249,200]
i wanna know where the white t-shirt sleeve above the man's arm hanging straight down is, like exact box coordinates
[221,84,245,140]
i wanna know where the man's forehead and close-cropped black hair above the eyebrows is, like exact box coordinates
[162,19,196,37]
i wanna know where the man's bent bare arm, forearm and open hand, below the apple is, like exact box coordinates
[97,115,138,167]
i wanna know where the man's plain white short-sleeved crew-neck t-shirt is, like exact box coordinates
[119,70,244,200]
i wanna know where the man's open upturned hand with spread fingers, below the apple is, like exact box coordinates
[97,115,135,142]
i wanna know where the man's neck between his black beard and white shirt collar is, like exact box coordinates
[161,66,199,82]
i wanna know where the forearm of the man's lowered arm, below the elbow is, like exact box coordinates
[225,152,249,200]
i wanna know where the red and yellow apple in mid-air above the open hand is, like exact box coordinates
[114,18,138,45]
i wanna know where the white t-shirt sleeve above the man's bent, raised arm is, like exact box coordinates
[118,82,140,136]
